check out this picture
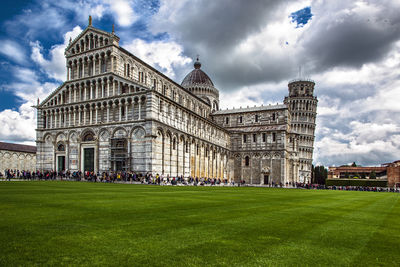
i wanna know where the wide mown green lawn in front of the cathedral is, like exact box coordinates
[0,182,400,266]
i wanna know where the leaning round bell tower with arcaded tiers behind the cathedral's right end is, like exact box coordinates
[285,79,318,183]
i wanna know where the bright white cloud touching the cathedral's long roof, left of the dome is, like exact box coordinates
[122,39,192,78]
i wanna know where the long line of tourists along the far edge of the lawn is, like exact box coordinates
[0,170,400,193]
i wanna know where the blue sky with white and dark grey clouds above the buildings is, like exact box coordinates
[0,0,400,168]
